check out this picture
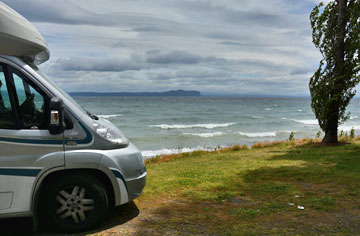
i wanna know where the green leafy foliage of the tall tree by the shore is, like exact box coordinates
[309,0,360,140]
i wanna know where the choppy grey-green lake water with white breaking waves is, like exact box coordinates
[74,96,360,157]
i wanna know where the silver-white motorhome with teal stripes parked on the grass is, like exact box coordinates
[0,2,146,231]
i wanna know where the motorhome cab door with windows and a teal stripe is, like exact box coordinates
[0,64,64,215]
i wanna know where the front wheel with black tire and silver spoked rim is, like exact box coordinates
[40,174,109,232]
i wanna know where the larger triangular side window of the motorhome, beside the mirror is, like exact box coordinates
[9,68,50,129]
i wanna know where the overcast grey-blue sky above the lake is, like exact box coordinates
[3,0,334,96]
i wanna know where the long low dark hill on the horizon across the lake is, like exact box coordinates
[70,90,201,97]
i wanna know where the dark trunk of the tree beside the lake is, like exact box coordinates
[322,0,348,144]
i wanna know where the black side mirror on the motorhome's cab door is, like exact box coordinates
[49,97,66,134]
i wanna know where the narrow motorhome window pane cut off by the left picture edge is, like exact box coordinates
[0,65,16,129]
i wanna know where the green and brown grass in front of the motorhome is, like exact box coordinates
[94,139,360,235]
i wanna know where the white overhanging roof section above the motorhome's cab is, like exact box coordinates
[0,2,50,65]
